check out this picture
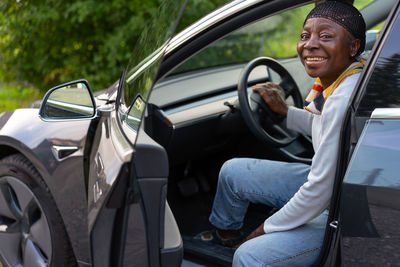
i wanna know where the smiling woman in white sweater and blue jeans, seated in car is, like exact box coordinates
[188,1,366,267]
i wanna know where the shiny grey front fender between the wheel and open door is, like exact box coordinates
[0,109,90,264]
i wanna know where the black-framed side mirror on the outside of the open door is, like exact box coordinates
[39,80,96,120]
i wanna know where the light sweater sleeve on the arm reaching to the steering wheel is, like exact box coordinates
[286,107,315,136]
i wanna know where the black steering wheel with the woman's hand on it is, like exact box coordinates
[238,57,303,147]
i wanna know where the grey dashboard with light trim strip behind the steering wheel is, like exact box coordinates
[149,57,314,125]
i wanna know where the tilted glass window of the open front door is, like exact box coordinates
[118,0,186,140]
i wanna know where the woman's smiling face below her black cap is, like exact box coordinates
[297,18,360,88]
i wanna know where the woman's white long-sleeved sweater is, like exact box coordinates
[264,73,360,233]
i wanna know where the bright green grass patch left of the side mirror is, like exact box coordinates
[0,83,42,113]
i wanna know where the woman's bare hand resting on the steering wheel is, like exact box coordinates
[252,82,288,117]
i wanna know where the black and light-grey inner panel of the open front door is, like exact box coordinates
[133,130,183,266]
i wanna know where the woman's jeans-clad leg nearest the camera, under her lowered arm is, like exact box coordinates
[233,213,328,267]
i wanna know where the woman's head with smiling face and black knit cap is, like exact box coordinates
[297,3,365,88]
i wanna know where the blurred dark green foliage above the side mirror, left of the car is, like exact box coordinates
[0,0,164,90]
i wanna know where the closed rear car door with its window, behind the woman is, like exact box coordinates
[332,2,400,266]
